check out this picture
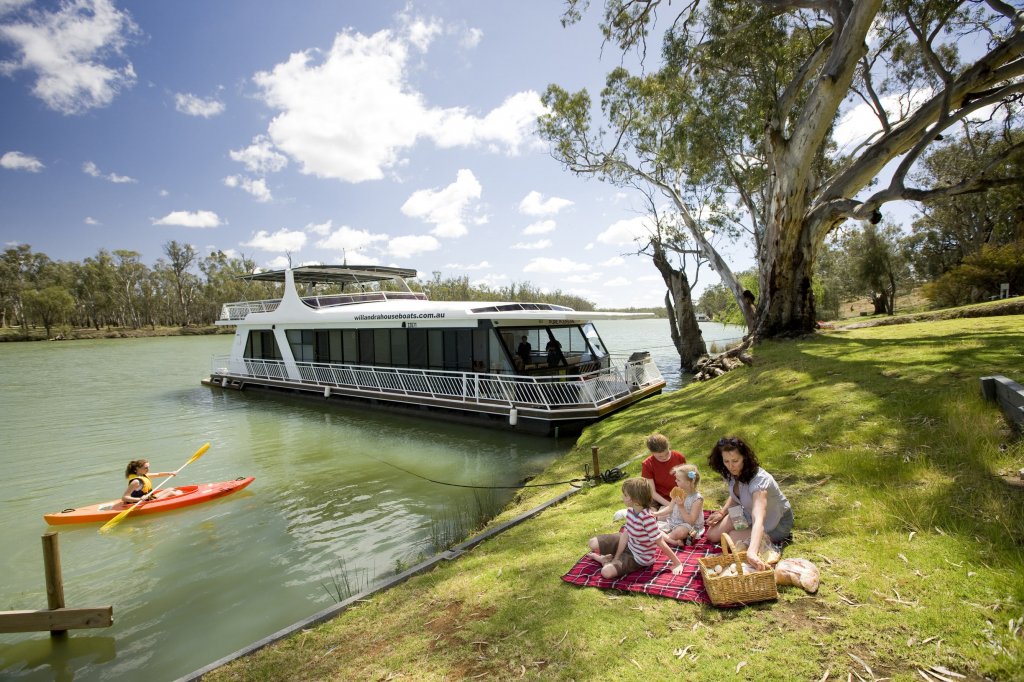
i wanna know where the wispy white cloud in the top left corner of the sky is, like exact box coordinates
[0,0,138,115]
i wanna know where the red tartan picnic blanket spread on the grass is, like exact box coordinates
[562,537,722,604]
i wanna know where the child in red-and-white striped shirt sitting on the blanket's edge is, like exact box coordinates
[588,478,683,579]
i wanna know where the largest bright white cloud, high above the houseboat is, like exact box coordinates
[253,20,543,182]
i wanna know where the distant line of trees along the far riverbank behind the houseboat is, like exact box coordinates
[0,241,594,337]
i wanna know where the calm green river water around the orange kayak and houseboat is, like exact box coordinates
[0,319,734,681]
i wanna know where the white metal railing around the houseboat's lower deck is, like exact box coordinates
[212,355,664,411]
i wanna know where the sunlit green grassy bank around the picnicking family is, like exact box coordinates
[207,315,1024,680]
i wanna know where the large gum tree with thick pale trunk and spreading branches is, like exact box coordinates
[541,0,1024,338]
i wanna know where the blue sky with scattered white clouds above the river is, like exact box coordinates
[0,0,745,307]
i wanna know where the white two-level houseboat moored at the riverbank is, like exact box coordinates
[204,265,665,435]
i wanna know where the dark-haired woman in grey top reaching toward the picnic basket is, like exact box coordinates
[706,437,793,569]
